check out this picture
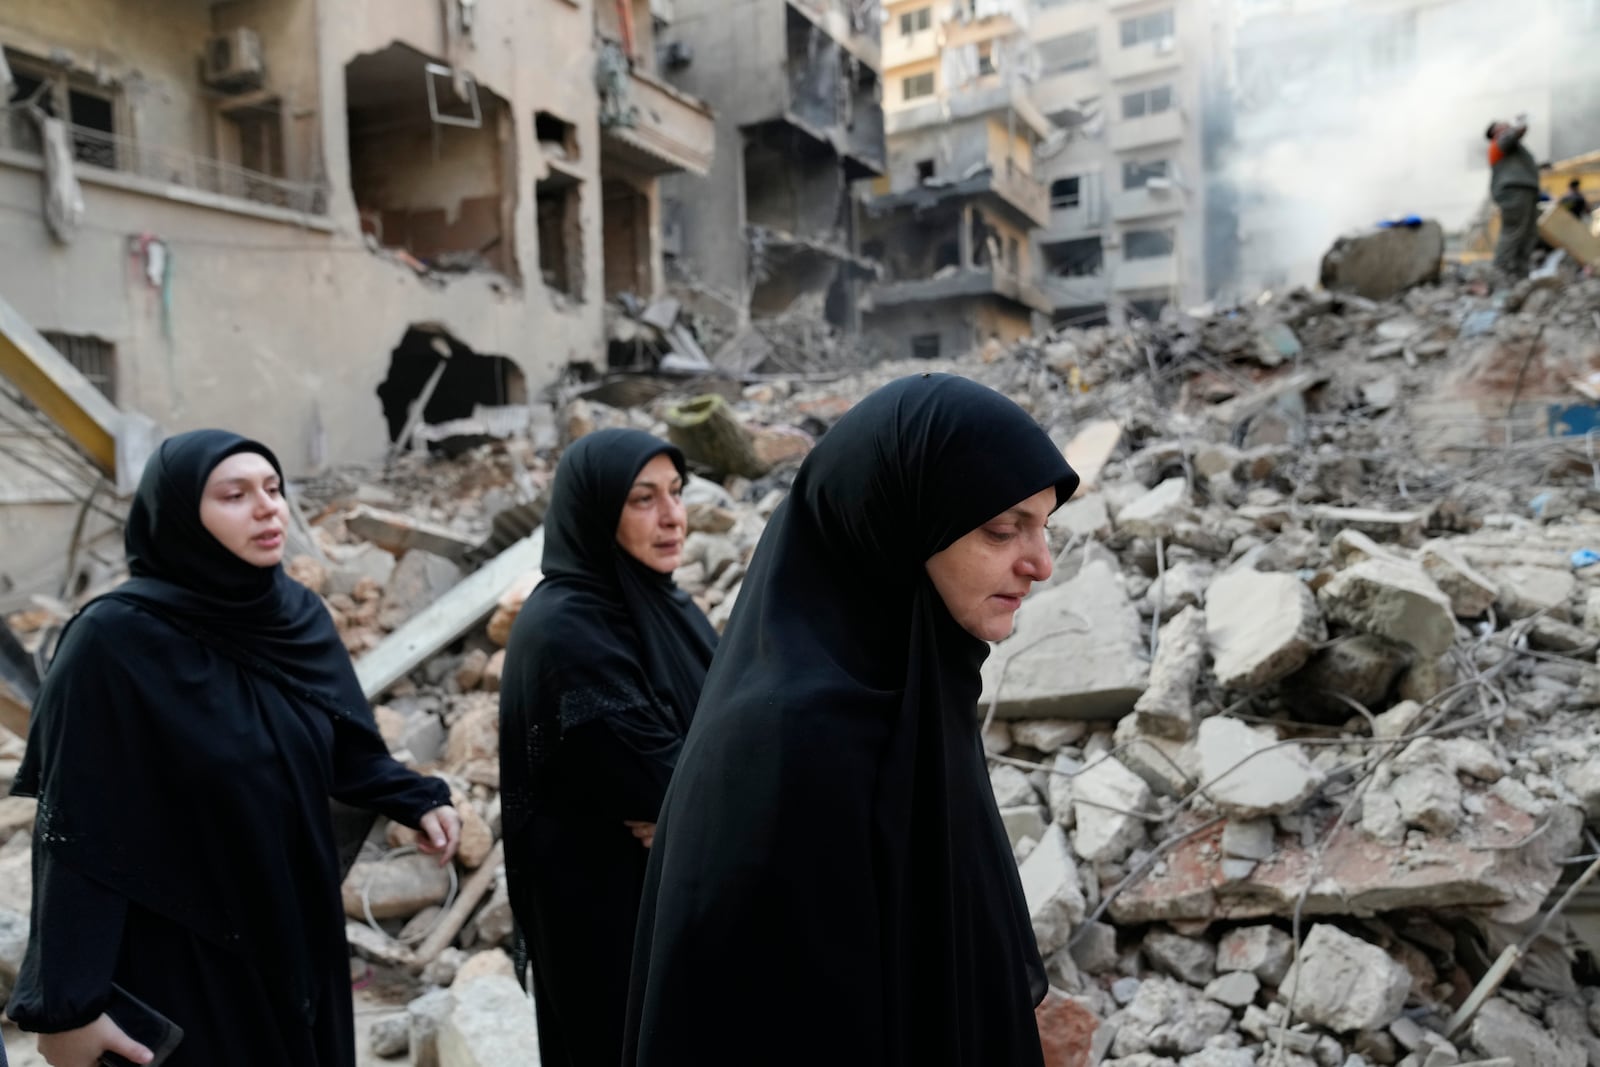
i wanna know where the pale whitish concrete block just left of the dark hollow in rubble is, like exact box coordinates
[1205,569,1328,689]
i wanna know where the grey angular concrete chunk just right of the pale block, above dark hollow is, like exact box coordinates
[1318,560,1456,656]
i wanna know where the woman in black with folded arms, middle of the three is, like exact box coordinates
[501,430,717,1067]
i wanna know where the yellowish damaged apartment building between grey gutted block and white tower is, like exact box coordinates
[861,0,1051,358]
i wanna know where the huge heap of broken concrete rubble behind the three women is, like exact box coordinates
[0,267,1600,1067]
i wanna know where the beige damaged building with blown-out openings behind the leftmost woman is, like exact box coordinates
[0,0,715,598]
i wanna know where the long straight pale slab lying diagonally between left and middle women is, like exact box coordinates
[355,526,544,699]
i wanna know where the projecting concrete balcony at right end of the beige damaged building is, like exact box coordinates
[600,70,717,178]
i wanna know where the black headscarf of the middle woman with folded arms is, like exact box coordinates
[501,430,717,840]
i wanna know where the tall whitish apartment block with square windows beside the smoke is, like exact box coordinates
[1030,0,1230,325]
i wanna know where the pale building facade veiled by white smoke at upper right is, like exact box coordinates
[1218,0,1600,299]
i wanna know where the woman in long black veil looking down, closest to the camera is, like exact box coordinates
[622,374,1078,1067]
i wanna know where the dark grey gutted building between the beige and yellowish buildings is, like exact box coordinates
[646,0,885,347]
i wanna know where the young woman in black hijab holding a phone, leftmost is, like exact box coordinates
[8,430,461,1067]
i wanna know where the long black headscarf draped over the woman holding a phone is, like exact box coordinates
[13,430,400,1009]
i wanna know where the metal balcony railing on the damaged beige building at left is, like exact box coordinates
[0,109,328,214]
